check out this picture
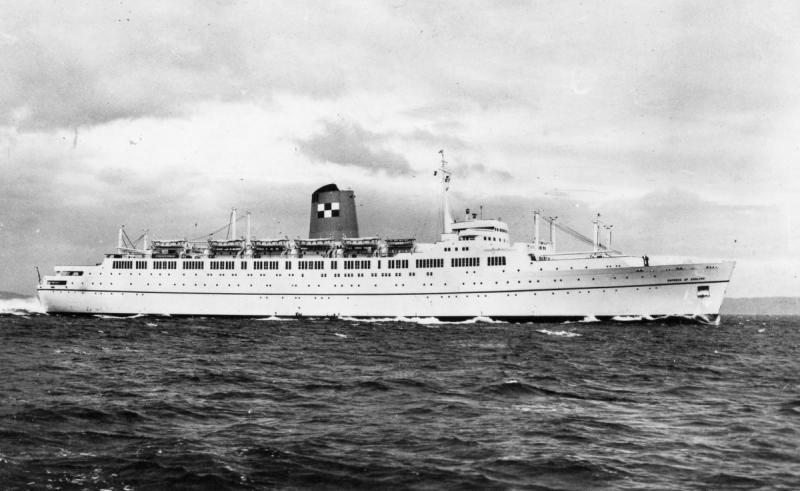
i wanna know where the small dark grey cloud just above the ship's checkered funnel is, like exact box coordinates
[297,121,411,175]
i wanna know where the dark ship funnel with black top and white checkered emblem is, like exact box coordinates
[308,184,358,240]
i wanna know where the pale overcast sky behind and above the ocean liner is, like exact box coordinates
[0,0,800,297]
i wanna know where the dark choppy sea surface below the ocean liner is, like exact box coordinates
[0,311,800,490]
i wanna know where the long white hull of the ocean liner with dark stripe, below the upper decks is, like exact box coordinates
[38,255,733,320]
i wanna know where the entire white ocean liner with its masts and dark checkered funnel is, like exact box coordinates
[37,153,734,322]
